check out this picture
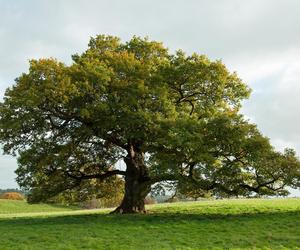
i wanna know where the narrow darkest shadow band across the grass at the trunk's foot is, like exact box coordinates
[0,207,300,227]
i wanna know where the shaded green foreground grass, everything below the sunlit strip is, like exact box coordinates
[0,211,300,249]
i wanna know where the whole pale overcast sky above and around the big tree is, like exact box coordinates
[0,0,300,195]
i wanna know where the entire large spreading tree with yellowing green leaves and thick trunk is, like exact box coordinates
[0,35,299,213]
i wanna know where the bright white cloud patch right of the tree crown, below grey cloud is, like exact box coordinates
[233,49,300,152]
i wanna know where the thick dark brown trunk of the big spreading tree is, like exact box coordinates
[112,147,151,214]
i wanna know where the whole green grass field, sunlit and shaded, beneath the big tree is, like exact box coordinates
[0,198,300,250]
